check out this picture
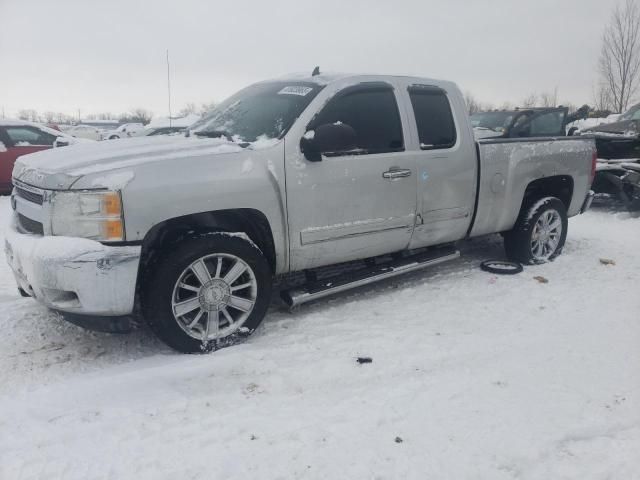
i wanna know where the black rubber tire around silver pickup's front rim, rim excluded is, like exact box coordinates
[142,232,273,353]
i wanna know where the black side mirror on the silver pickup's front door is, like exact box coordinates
[300,123,356,162]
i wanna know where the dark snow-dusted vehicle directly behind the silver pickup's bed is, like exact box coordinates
[471,107,573,138]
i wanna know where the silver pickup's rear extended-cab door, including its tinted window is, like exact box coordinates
[405,84,477,248]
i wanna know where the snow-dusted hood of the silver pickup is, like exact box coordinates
[13,136,278,190]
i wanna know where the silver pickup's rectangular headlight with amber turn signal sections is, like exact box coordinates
[51,191,125,242]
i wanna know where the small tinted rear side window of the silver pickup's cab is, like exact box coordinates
[409,86,456,150]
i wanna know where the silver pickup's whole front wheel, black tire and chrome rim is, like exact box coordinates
[142,232,272,353]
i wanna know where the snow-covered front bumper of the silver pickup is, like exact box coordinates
[5,227,141,316]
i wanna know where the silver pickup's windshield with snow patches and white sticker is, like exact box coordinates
[190,82,322,143]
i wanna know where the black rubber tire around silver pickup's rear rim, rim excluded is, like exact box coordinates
[504,197,569,265]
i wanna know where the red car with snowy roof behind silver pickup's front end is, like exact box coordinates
[0,120,77,194]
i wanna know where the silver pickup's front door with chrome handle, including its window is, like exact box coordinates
[285,82,416,270]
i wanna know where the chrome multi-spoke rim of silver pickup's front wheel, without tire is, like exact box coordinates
[171,253,258,342]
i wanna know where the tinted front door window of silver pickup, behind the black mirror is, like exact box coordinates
[308,85,404,154]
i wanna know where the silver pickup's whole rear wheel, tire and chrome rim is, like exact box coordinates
[504,197,569,265]
